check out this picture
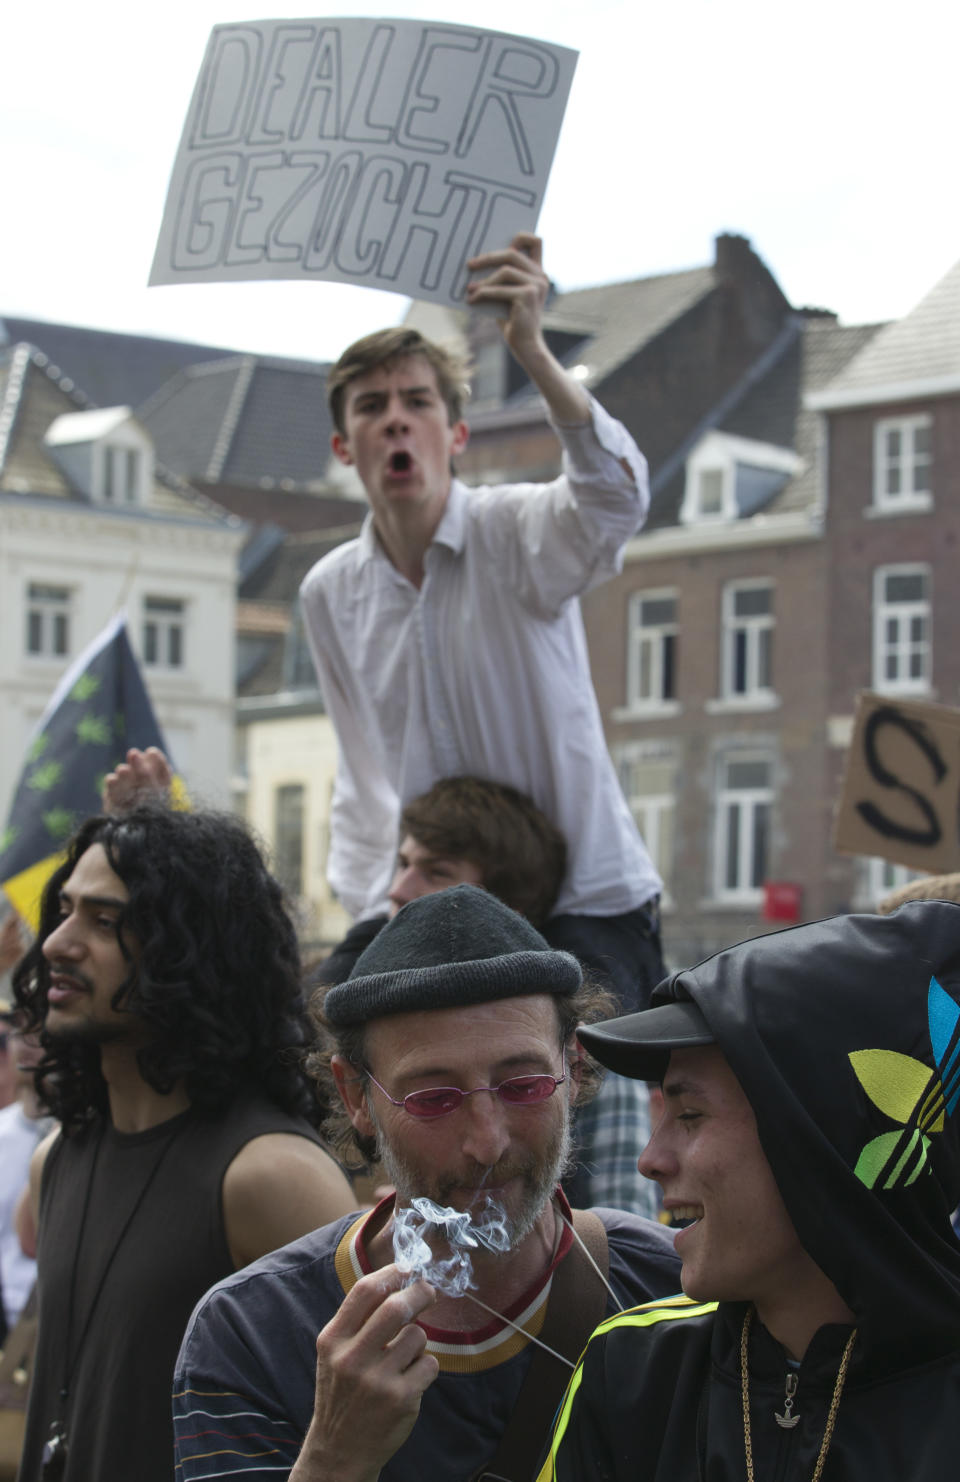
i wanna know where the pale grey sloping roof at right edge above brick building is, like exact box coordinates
[810,251,960,411]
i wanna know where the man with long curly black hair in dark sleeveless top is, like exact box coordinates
[13,805,356,1482]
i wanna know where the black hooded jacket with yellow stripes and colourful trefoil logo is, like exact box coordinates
[541,901,960,1482]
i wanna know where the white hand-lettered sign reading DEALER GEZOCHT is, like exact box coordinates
[150,19,576,304]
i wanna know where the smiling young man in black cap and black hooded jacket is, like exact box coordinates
[541,901,960,1482]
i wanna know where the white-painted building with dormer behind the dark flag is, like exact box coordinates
[0,344,244,820]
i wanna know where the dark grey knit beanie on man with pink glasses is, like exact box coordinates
[323,885,584,1029]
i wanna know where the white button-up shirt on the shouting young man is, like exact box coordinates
[301,402,661,917]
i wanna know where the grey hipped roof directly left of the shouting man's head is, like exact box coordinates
[138,356,332,489]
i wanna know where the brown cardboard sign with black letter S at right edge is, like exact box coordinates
[834,694,960,874]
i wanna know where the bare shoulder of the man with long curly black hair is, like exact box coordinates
[224,1132,357,1267]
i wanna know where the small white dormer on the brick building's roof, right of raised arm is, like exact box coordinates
[680,433,803,525]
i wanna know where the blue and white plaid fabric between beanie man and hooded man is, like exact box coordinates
[576,1070,659,1220]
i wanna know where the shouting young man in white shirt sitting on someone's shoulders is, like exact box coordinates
[302,234,662,1009]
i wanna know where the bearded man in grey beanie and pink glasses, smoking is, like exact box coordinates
[173,885,679,1482]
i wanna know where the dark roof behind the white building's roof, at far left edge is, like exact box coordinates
[0,316,236,406]
